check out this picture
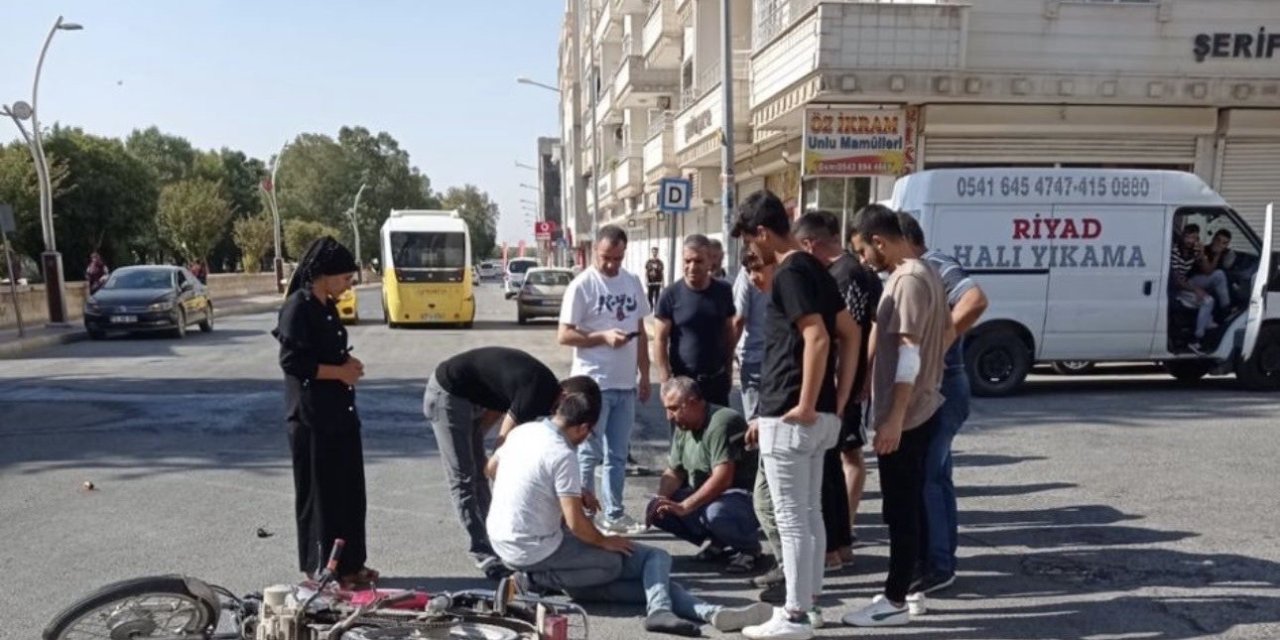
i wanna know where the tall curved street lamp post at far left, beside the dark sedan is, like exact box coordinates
[4,15,84,325]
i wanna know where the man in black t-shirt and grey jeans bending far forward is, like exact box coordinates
[422,347,591,579]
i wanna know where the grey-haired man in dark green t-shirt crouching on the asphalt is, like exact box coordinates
[645,376,760,573]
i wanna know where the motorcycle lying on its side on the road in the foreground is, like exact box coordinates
[42,540,588,640]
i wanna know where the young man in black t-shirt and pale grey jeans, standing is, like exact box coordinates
[733,191,858,637]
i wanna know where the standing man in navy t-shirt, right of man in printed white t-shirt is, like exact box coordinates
[653,234,733,407]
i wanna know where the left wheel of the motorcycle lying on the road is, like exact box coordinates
[41,576,219,640]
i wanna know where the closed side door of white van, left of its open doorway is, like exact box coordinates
[1033,204,1170,360]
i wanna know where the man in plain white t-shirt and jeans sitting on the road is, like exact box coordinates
[485,376,772,636]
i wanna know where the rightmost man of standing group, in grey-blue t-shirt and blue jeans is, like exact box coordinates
[899,212,987,594]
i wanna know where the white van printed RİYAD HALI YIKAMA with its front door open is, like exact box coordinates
[887,168,1280,396]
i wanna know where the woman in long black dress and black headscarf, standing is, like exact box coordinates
[273,237,378,586]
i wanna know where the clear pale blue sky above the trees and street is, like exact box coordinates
[0,0,563,241]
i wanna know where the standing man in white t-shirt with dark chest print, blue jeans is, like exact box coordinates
[558,224,649,532]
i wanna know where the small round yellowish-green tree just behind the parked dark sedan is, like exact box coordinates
[156,178,232,262]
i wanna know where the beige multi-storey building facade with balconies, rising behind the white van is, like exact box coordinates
[561,0,1280,271]
